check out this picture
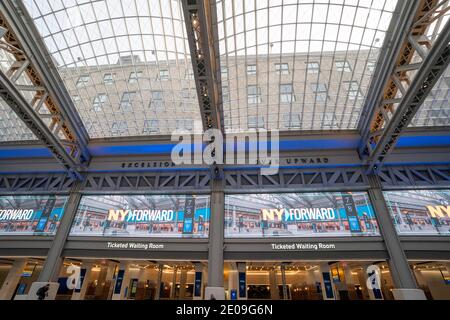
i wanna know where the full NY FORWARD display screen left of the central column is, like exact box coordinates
[70,195,210,238]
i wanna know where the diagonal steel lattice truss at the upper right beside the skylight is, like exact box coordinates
[359,0,450,170]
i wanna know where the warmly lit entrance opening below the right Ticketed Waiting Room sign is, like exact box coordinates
[224,261,393,300]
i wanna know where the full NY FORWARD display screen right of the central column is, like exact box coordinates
[225,192,380,238]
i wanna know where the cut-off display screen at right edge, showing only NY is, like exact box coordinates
[383,190,450,235]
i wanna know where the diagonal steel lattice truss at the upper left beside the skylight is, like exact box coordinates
[0,0,90,178]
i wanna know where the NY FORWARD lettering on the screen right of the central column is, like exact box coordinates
[261,208,336,221]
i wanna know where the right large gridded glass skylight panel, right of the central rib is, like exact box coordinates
[217,0,397,131]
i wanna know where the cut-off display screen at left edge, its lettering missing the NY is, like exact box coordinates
[0,195,68,236]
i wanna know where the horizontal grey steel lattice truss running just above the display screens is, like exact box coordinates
[0,165,450,194]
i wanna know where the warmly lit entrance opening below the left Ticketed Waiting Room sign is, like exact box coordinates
[56,258,207,300]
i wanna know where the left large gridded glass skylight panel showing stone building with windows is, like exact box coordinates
[24,0,201,138]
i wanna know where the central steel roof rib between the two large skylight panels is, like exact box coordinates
[182,0,223,131]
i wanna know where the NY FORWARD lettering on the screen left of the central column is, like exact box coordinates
[108,209,175,222]
